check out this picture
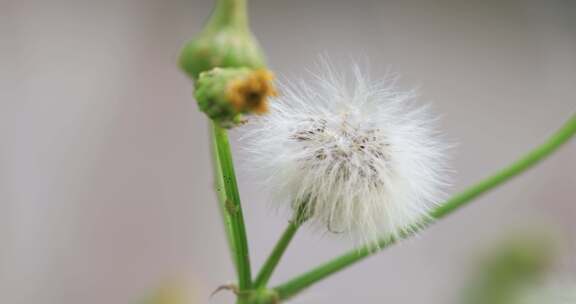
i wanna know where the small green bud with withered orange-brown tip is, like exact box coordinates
[195,68,277,128]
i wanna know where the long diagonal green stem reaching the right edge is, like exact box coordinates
[274,115,576,299]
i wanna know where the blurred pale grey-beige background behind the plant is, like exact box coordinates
[0,0,576,304]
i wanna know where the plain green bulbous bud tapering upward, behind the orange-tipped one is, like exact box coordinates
[180,0,265,80]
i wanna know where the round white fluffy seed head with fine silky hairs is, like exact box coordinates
[238,61,447,244]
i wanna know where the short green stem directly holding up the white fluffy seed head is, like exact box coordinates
[254,220,301,289]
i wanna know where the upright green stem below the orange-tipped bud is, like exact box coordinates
[212,122,252,291]
